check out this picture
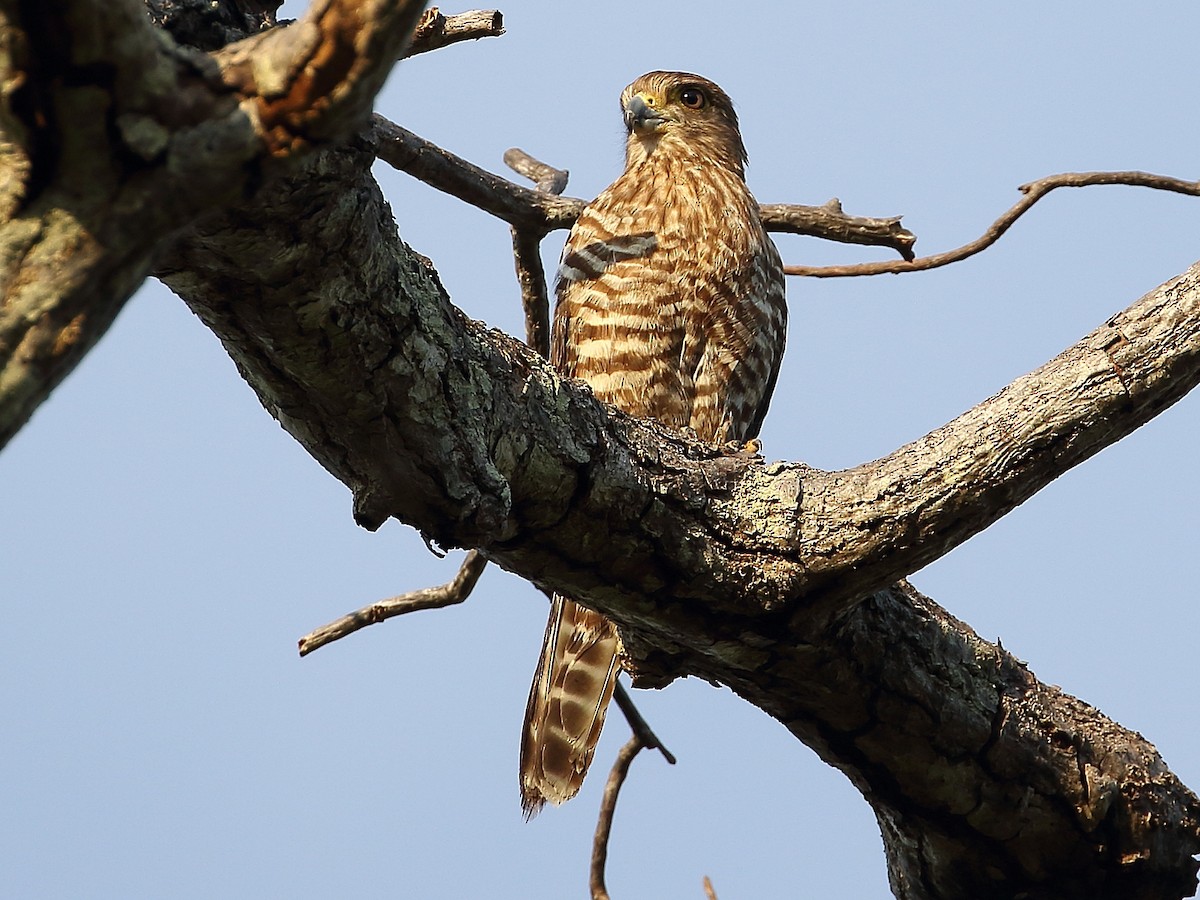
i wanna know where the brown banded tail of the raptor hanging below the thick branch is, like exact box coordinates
[521,594,620,818]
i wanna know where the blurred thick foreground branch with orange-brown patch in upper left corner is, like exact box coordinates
[0,0,424,448]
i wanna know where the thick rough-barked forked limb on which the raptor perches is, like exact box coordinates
[0,0,1200,899]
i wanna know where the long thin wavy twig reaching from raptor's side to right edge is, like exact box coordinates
[784,172,1200,278]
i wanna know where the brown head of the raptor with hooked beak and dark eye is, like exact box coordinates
[620,72,746,175]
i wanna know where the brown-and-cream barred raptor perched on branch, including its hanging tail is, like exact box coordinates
[521,72,787,816]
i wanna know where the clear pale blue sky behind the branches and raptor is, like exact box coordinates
[0,0,1200,900]
